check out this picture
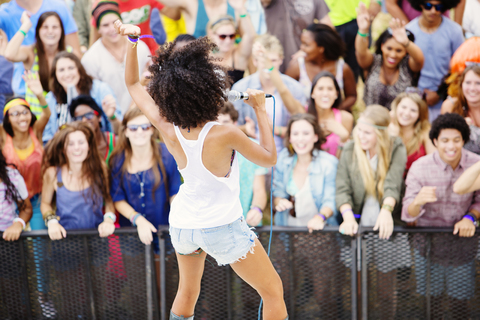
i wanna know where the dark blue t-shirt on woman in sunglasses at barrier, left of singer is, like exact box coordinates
[110,143,181,247]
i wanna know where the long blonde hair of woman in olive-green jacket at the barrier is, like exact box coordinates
[353,105,392,199]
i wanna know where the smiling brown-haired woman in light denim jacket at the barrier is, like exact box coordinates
[273,114,338,232]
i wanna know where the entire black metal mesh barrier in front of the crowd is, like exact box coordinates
[0,227,480,320]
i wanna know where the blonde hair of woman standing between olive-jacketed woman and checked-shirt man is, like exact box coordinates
[391,92,430,155]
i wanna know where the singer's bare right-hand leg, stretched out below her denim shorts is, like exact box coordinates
[230,239,287,320]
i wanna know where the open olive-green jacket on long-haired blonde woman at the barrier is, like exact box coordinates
[335,137,407,224]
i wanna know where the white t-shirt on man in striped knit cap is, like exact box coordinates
[82,38,150,115]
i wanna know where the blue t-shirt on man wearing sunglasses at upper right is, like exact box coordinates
[405,17,464,121]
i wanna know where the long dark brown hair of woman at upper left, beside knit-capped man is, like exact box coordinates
[35,11,65,91]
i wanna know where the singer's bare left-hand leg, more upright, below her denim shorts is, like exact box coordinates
[172,251,207,319]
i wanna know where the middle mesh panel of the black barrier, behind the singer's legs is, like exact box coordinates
[162,229,355,320]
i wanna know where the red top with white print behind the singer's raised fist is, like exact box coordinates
[118,0,164,55]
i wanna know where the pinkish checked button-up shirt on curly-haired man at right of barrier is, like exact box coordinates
[402,149,480,227]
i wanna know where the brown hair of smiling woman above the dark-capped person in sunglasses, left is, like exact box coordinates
[50,51,93,104]
